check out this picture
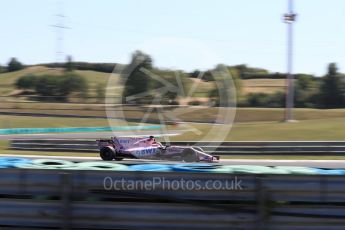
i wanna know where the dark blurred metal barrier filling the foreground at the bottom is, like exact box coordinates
[0,169,345,230]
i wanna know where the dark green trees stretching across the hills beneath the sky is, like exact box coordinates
[4,51,345,108]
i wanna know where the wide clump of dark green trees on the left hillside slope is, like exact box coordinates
[16,73,88,101]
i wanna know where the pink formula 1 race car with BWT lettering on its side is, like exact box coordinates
[97,136,219,162]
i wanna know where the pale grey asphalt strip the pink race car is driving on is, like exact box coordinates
[0,154,345,169]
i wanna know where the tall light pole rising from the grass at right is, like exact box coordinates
[284,0,296,122]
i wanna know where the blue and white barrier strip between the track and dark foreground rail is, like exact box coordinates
[0,157,345,175]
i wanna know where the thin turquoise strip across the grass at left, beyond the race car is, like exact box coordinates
[0,125,161,135]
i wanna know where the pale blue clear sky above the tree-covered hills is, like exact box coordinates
[0,0,345,75]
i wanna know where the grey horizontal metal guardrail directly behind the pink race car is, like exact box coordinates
[11,139,345,156]
